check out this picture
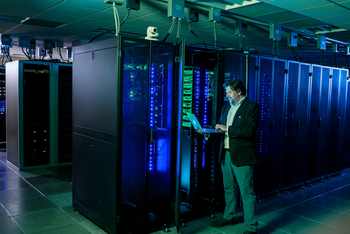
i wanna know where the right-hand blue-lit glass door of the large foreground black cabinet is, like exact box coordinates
[147,44,175,222]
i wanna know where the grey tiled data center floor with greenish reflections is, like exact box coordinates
[0,149,350,234]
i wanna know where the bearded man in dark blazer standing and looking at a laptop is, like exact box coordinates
[200,80,260,234]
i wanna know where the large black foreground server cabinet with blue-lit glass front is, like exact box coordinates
[73,37,176,233]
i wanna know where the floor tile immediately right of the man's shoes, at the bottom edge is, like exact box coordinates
[258,211,319,234]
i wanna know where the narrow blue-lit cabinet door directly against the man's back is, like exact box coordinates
[255,57,273,195]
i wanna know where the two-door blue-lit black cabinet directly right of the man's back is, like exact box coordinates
[255,57,287,195]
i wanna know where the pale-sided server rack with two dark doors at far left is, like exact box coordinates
[6,61,72,170]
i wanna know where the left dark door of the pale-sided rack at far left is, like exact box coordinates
[20,63,52,167]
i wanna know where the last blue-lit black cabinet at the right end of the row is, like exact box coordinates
[326,68,347,174]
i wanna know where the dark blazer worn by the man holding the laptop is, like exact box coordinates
[218,98,260,166]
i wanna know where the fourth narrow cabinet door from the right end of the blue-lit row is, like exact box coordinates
[307,65,324,180]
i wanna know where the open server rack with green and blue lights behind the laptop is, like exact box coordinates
[181,49,219,219]
